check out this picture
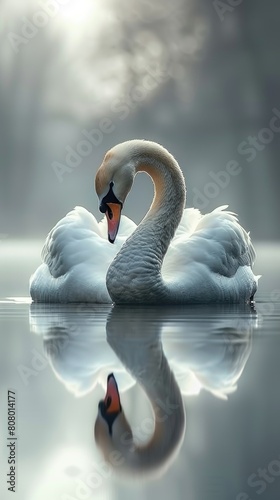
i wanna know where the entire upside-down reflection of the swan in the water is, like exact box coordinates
[30,304,256,475]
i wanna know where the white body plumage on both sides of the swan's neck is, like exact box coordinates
[30,206,256,303]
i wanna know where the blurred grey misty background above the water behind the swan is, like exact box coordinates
[0,0,280,241]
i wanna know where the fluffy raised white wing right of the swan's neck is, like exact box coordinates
[163,206,255,286]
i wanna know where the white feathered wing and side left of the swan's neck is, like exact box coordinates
[30,207,135,302]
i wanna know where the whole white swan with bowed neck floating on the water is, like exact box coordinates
[30,140,259,303]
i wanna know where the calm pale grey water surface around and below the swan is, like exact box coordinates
[0,241,280,500]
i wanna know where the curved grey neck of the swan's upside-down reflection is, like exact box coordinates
[106,314,185,473]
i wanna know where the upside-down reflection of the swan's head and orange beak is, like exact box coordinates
[94,373,132,468]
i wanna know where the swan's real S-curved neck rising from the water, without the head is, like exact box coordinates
[106,143,186,303]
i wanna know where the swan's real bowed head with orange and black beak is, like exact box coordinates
[95,141,135,243]
